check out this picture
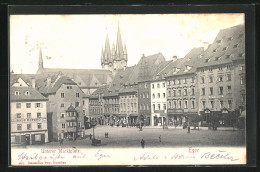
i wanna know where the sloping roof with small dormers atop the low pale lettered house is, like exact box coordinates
[10,86,48,102]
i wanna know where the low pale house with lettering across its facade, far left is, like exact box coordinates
[10,76,48,145]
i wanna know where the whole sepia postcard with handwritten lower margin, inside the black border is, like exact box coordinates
[9,13,247,166]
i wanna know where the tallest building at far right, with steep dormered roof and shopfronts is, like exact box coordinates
[197,25,246,126]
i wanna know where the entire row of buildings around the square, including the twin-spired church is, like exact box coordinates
[10,25,246,144]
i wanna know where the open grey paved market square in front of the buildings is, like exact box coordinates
[27,126,245,148]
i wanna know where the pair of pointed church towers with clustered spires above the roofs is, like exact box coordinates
[101,26,127,73]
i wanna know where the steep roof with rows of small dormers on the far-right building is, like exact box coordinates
[199,25,245,67]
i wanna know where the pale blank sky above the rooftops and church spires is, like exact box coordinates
[10,13,244,74]
